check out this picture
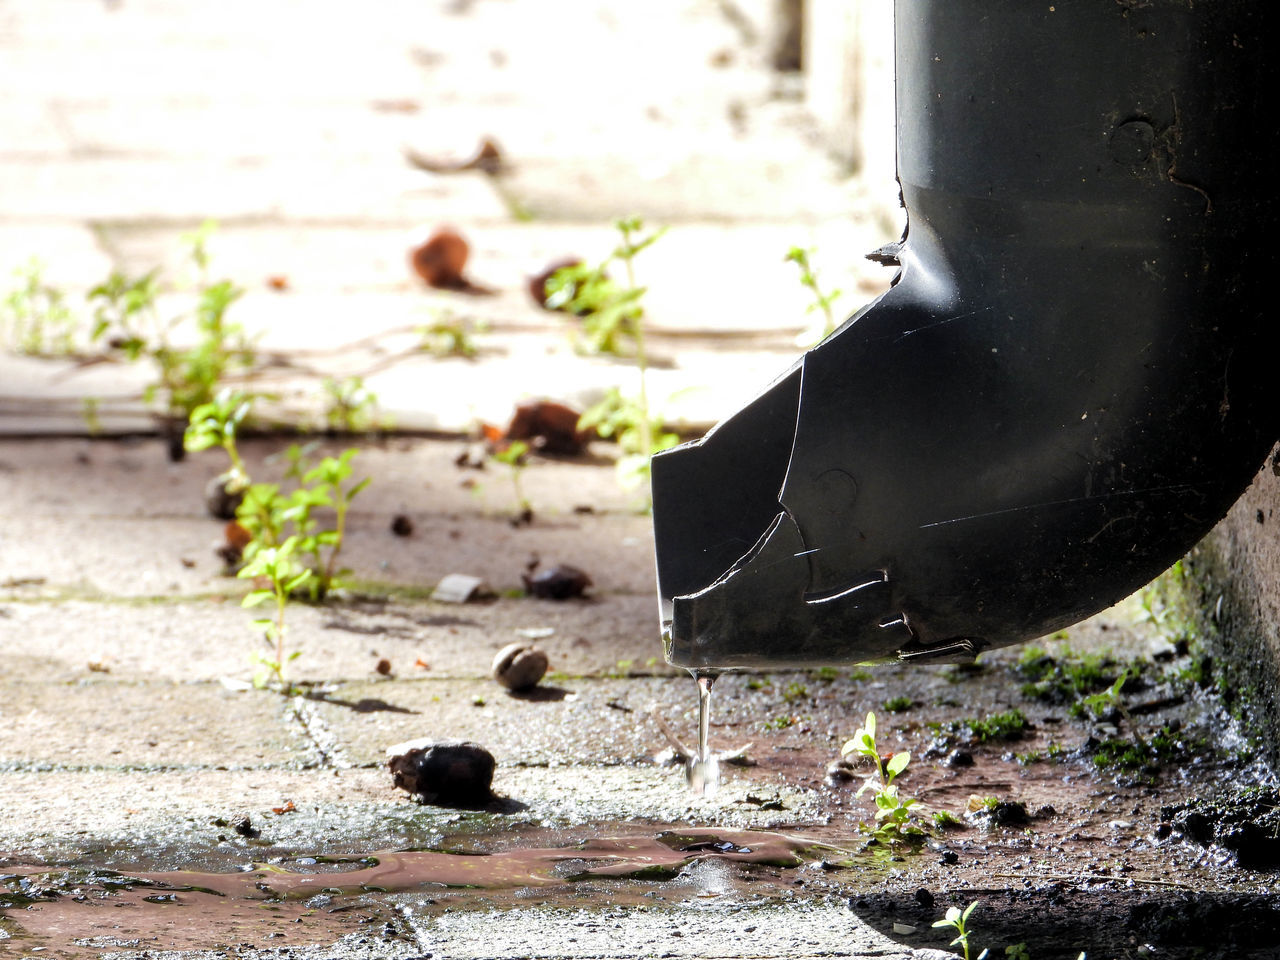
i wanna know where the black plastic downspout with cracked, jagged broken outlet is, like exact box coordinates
[653,0,1280,669]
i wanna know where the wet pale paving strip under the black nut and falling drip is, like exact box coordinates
[0,762,819,870]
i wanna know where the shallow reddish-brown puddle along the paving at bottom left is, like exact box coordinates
[0,829,851,956]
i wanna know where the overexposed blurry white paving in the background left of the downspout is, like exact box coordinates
[0,0,902,434]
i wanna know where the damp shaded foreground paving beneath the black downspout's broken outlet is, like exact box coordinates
[0,439,1280,960]
